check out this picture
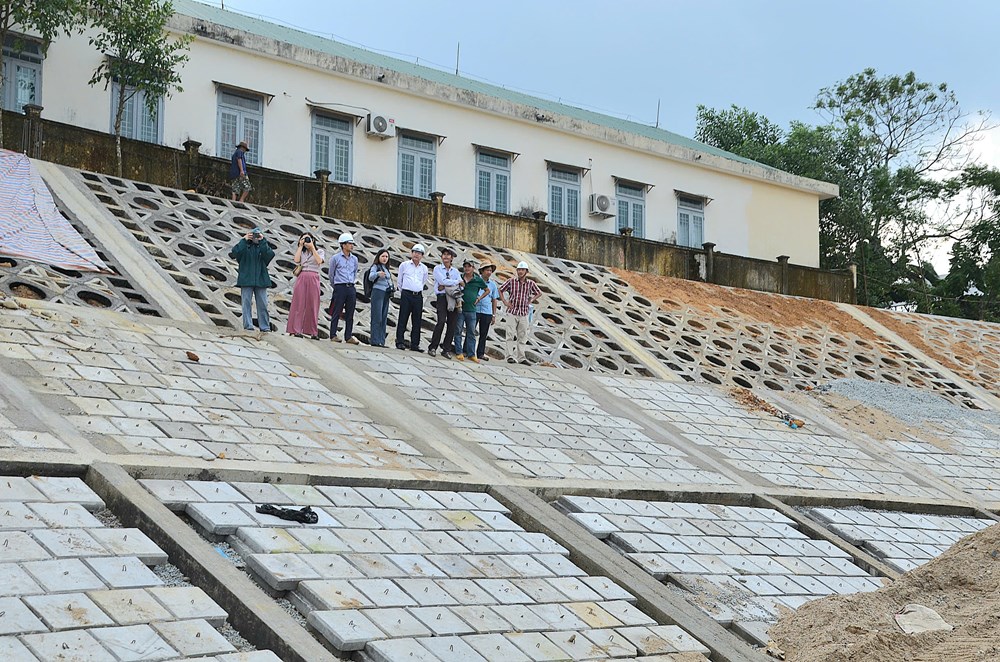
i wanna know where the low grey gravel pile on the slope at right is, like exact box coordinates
[816,379,1000,425]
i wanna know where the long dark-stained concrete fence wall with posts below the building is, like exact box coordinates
[2,106,855,303]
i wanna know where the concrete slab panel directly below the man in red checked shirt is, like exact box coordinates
[345,350,733,485]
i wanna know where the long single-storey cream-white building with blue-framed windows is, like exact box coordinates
[2,0,837,266]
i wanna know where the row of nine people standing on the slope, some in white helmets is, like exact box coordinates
[230,228,542,364]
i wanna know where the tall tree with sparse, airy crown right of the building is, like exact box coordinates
[815,69,988,307]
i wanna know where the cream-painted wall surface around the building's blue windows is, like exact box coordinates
[35,26,819,266]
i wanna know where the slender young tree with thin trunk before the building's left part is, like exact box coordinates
[90,0,192,177]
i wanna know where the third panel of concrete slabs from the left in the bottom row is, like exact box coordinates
[553,497,881,640]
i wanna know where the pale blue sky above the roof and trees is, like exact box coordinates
[201,0,1000,271]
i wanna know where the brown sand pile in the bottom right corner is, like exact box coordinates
[770,526,1000,662]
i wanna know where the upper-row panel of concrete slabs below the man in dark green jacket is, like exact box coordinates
[0,311,458,478]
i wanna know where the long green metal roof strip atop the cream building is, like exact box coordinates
[172,0,777,170]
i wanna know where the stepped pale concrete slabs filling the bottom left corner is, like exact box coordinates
[0,475,282,662]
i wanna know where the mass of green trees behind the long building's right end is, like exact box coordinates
[697,69,1000,311]
